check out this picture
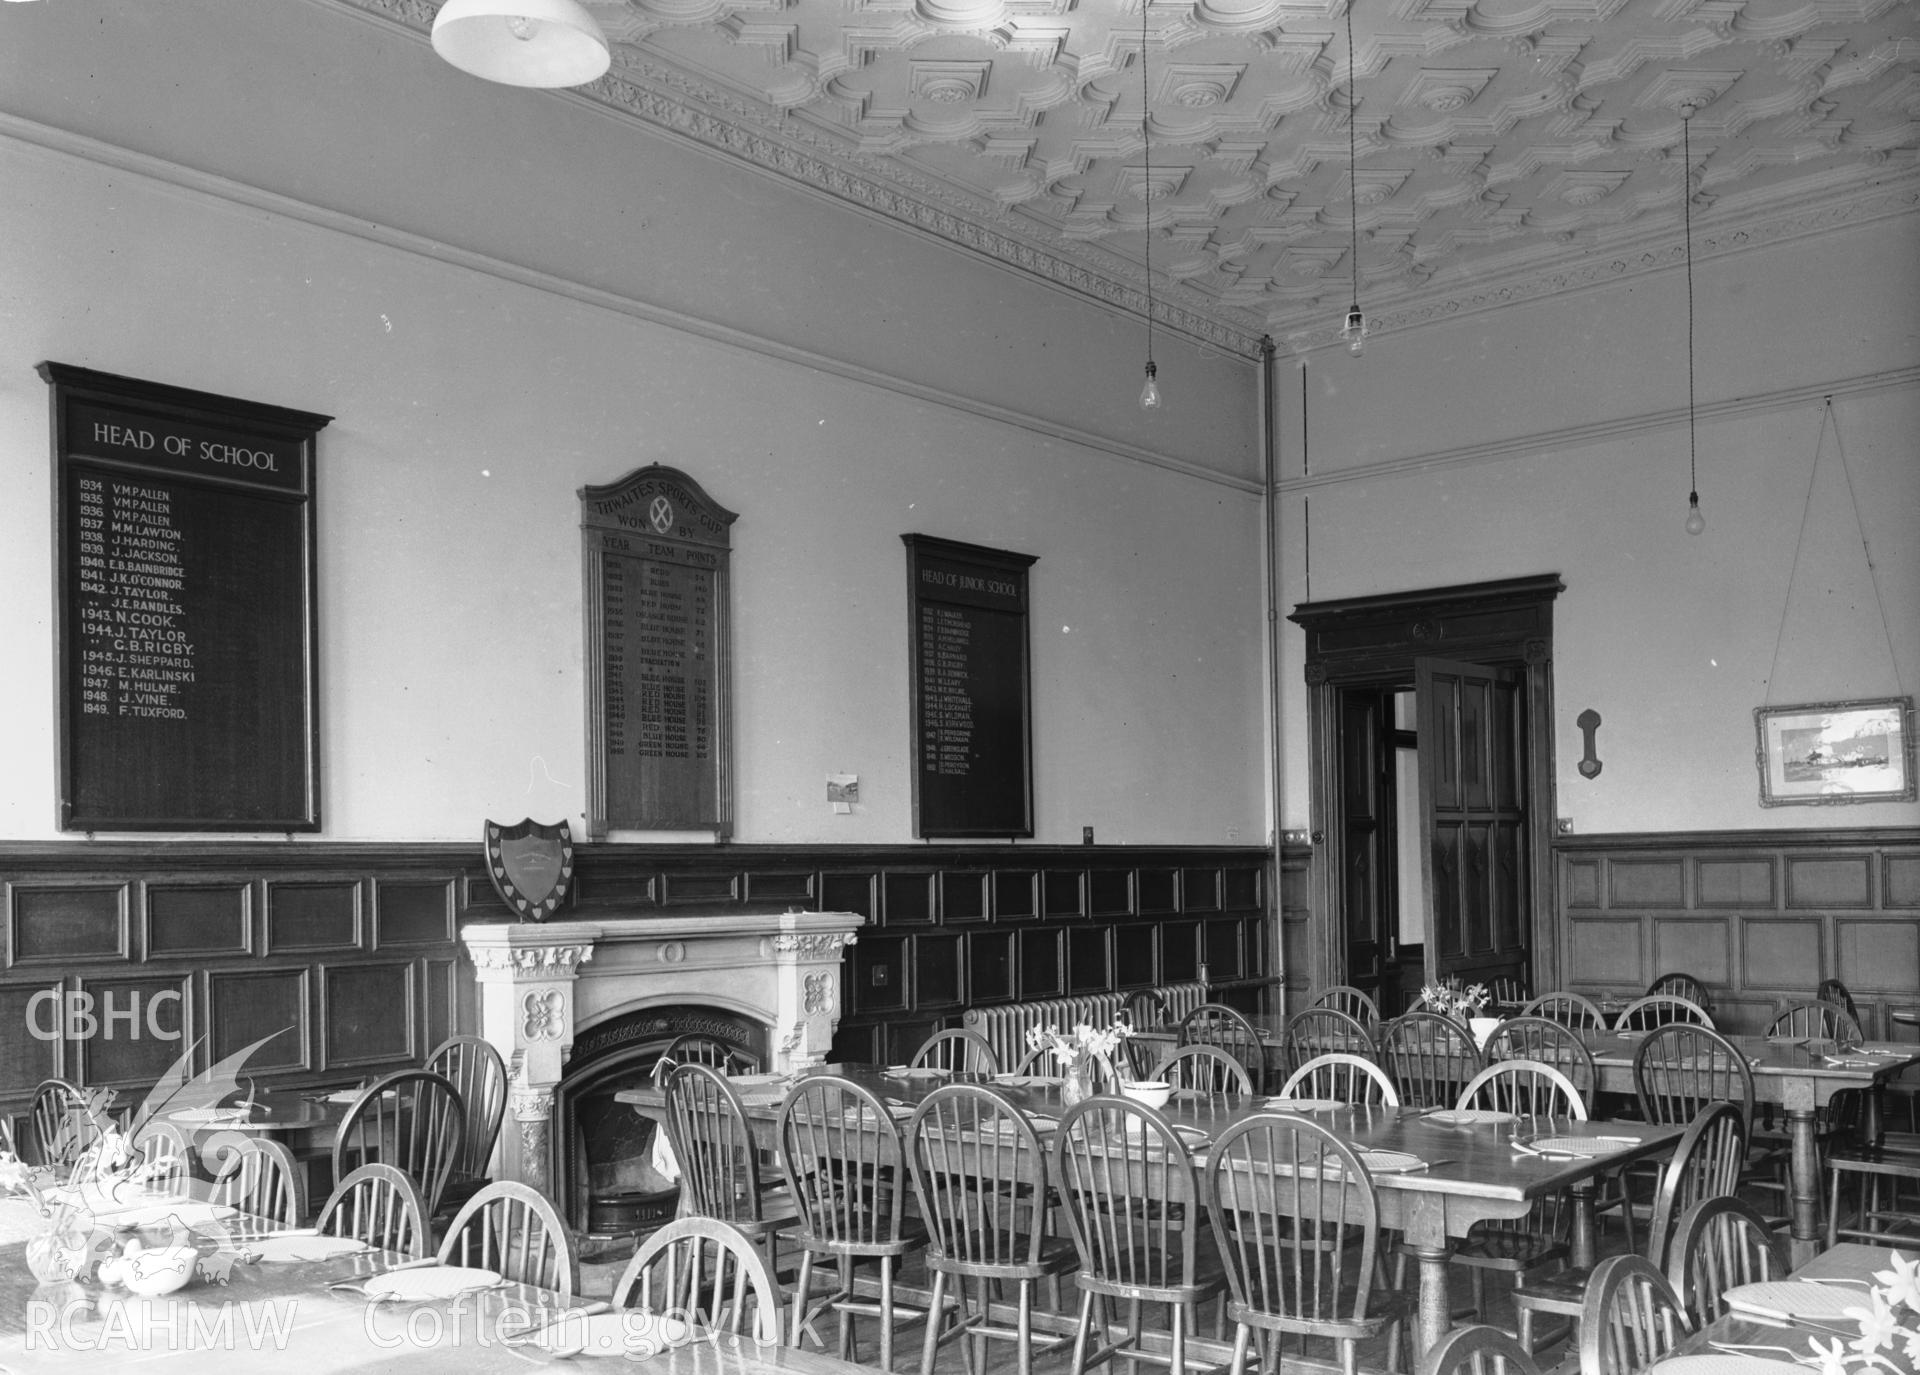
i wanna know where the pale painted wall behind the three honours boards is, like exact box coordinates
[0,0,1267,843]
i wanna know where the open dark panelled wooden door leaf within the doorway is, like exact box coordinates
[1413,659,1528,987]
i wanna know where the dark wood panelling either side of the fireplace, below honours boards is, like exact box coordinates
[0,841,1271,1112]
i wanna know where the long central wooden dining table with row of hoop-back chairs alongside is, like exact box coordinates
[614,1064,1682,1352]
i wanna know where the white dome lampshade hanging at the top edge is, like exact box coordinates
[434,0,612,88]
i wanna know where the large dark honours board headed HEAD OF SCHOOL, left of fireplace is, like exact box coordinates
[40,363,328,832]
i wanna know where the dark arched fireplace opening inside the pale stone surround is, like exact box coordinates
[553,1004,766,1242]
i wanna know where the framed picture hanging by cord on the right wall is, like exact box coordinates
[1753,697,1914,807]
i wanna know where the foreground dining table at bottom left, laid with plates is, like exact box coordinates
[0,1214,874,1375]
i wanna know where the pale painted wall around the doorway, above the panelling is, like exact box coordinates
[1281,215,1920,833]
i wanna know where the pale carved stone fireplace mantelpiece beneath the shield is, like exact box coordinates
[461,912,862,1194]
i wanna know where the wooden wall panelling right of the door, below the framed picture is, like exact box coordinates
[1555,828,1920,1041]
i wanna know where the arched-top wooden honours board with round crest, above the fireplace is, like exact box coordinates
[580,465,733,837]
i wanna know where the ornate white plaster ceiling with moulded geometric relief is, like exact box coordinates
[349,0,1920,350]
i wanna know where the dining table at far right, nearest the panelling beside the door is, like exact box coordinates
[1580,1031,1920,1266]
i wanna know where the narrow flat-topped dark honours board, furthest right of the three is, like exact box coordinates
[900,534,1035,837]
